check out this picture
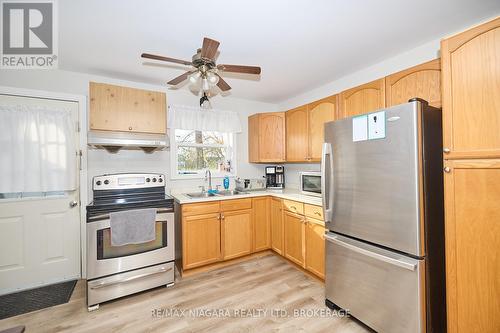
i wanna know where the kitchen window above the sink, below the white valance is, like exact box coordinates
[171,129,236,179]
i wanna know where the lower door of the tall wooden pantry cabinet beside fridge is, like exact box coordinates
[445,159,500,333]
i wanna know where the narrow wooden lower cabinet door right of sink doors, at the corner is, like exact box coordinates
[252,197,271,251]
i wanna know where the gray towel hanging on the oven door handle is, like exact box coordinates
[109,208,156,246]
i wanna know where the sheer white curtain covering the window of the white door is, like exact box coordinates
[0,105,76,193]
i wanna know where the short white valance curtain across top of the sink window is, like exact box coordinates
[167,105,241,133]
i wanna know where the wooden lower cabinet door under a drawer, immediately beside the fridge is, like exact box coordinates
[305,218,325,279]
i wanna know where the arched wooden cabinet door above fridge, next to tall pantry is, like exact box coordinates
[385,59,441,108]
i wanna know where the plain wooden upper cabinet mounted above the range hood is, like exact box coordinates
[89,82,167,134]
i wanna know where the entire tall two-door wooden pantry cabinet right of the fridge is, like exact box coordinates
[441,18,500,333]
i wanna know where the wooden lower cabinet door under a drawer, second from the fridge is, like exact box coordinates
[283,211,305,267]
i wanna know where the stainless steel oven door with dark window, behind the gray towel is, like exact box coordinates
[87,209,174,280]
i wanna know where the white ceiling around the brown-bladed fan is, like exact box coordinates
[58,0,500,103]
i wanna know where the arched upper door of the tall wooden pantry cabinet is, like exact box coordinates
[441,18,500,158]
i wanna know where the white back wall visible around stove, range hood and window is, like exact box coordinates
[0,70,278,196]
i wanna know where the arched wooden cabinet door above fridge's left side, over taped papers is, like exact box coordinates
[339,78,385,118]
